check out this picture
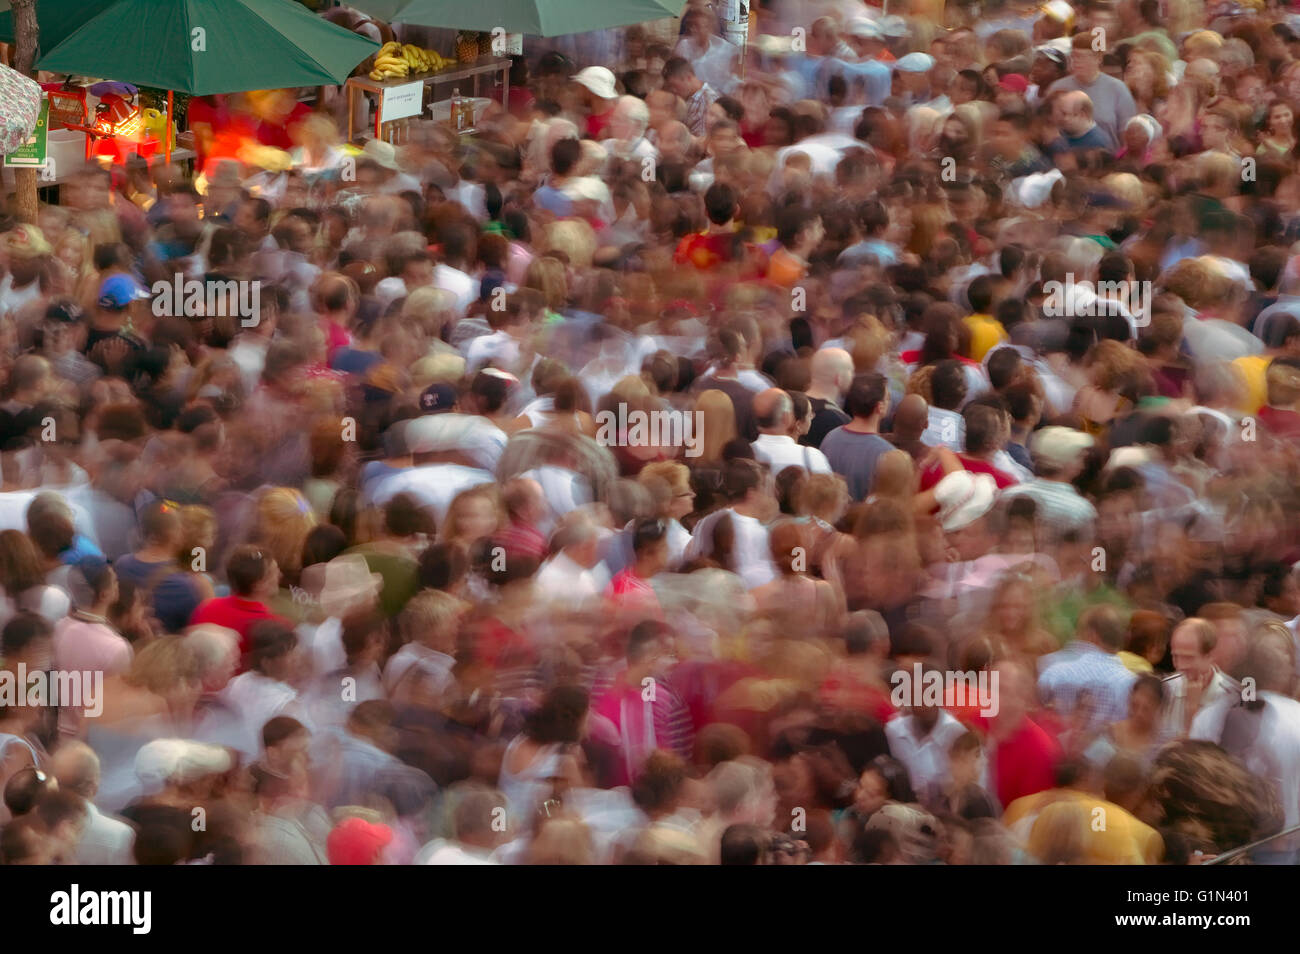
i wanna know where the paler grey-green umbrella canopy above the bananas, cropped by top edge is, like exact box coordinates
[348,0,685,36]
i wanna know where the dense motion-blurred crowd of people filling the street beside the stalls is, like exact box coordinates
[0,0,1300,864]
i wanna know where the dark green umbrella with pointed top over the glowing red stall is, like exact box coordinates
[36,0,378,96]
